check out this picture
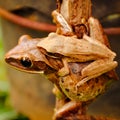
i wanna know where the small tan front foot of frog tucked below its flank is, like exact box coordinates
[58,58,69,77]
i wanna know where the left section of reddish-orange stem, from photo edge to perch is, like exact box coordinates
[0,8,56,32]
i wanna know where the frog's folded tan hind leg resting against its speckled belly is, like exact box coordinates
[76,59,117,87]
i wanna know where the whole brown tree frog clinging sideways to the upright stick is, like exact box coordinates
[5,14,117,101]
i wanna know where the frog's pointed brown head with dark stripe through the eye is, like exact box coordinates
[5,35,49,73]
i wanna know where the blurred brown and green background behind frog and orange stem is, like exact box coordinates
[0,0,120,120]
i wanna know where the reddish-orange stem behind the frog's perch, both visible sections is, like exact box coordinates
[0,8,120,35]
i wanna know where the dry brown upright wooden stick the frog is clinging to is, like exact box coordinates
[54,0,117,120]
